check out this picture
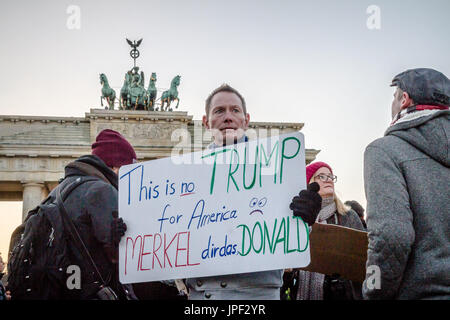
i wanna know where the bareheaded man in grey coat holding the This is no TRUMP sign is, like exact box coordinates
[186,84,321,300]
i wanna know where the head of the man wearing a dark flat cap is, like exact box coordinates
[391,68,450,119]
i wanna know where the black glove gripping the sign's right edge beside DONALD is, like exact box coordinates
[289,182,322,226]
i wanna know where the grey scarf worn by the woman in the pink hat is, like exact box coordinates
[297,197,336,300]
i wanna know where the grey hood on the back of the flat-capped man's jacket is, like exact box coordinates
[384,110,450,167]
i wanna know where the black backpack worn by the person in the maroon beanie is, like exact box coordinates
[8,178,94,300]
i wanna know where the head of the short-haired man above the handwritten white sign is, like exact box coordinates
[203,84,250,145]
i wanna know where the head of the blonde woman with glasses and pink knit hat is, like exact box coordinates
[306,161,349,214]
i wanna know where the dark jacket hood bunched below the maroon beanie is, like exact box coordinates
[64,154,118,189]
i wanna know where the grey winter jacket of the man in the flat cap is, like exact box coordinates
[363,110,450,299]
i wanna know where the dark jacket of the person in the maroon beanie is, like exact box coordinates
[52,155,129,299]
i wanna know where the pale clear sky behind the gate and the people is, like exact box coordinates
[0,0,450,257]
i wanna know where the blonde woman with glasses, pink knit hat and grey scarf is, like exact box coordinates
[291,161,364,300]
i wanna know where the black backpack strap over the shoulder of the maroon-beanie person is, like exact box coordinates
[55,177,110,286]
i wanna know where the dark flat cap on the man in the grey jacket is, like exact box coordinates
[391,68,450,107]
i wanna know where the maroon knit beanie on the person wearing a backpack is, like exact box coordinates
[92,129,137,168]
